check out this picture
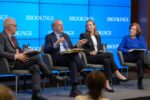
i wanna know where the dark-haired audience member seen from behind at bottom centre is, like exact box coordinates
[75,71,109,100]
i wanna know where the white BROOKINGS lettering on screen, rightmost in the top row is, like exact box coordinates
[107,17,129,22]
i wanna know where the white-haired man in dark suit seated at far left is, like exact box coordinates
[0,18,65,100]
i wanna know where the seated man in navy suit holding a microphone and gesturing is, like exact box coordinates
[44,20,86,97]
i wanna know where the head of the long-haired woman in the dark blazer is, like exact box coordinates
[86,20,98,36]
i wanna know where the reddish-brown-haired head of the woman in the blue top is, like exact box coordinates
[129,23,141,37]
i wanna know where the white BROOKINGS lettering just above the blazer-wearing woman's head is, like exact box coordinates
[69,16,94,21]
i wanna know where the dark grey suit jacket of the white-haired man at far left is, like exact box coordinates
[0,31,20,69]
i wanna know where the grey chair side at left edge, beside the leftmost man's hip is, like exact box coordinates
[0,58,10,74]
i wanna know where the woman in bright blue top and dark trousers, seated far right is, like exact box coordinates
[118,23,147,89]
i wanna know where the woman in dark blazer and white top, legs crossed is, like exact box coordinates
[80,20,127,92]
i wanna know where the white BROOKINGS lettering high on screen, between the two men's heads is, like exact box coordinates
[26,15,54,21]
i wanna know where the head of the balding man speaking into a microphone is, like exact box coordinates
[52,20,64,33]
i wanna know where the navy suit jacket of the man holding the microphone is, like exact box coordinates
[44,32,73,57]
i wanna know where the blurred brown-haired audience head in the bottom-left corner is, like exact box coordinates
[0,85,15,100]
